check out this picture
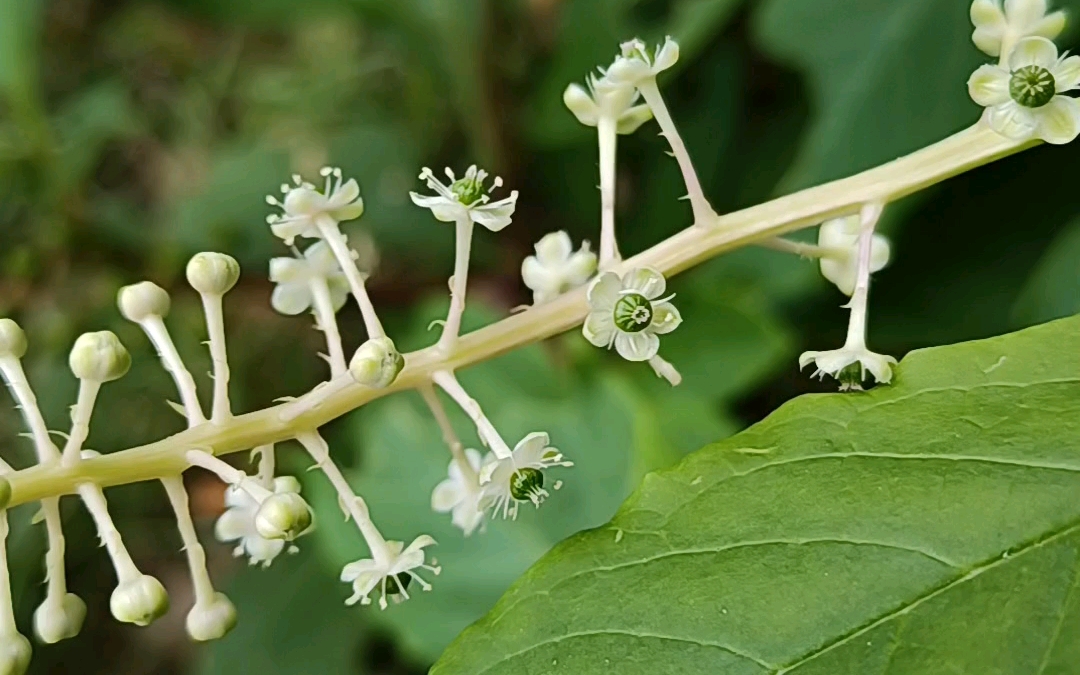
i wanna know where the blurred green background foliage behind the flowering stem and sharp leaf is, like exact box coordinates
[0,0,1080,675]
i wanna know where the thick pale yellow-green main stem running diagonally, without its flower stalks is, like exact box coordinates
[0,124,1038,505]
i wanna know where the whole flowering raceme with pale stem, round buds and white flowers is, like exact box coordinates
[0,0,1080,675]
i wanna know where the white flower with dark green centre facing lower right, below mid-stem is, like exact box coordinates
[480,431,573,518]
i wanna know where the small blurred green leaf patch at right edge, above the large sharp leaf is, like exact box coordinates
[1013,219,1080,325]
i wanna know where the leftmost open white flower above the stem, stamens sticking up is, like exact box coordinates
[267,166,364,244]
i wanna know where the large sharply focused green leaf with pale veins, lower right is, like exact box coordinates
[432,319,1080,675]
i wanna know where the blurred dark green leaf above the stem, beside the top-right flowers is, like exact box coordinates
[755,0,987,190]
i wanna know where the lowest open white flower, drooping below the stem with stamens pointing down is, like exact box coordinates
[341,535,442,609]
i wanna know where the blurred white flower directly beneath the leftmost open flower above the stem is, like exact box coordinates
[270,237,349,316]
